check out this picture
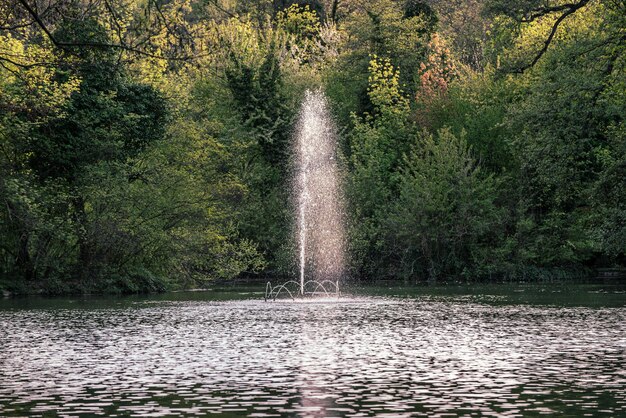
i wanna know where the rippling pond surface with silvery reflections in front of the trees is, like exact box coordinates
[0,290,626,417]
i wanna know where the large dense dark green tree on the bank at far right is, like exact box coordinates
[508,3,624,265]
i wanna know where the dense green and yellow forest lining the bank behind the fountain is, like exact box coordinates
[0,0,626,294]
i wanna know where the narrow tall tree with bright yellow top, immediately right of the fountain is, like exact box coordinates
[348,56,413,277]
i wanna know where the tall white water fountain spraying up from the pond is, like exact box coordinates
[265,89,345,300]
